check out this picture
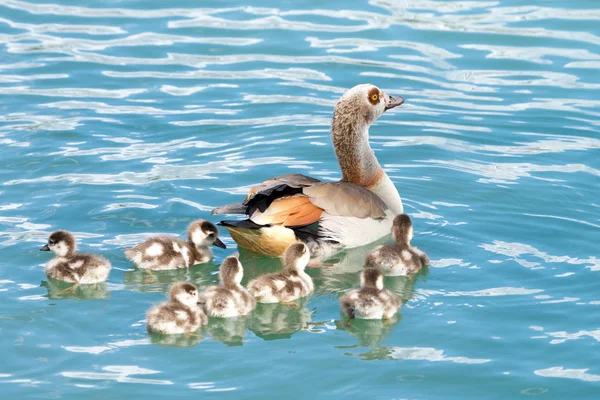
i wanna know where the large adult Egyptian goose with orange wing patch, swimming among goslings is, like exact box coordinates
[213,84,404,256]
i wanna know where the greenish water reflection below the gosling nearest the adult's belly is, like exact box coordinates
[248,298,311,340]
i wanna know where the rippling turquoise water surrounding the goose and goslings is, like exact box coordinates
[0,0,600,399]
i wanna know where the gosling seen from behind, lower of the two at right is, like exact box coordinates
[340,268,401,319]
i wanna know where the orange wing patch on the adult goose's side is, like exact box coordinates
[250,195,323,226]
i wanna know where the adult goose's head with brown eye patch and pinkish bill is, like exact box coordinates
[333,83,404,126]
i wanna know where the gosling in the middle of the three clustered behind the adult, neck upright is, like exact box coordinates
[199,256,256,318]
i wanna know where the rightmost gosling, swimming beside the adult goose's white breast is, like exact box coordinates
[365,214,429,275]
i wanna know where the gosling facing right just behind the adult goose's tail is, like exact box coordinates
[125,219,226,270]
